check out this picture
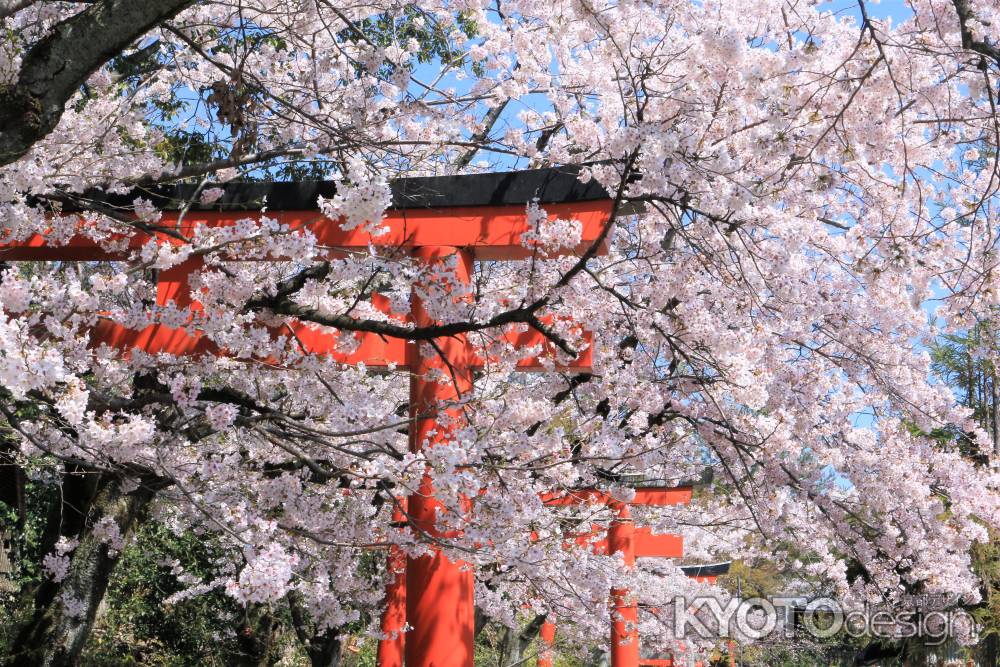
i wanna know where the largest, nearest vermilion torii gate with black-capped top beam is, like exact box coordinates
[0,169,612,667]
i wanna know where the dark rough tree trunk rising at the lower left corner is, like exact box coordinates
[9,474,154,667]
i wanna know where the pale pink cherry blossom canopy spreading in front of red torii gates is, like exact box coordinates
[0,0,1000,664]
